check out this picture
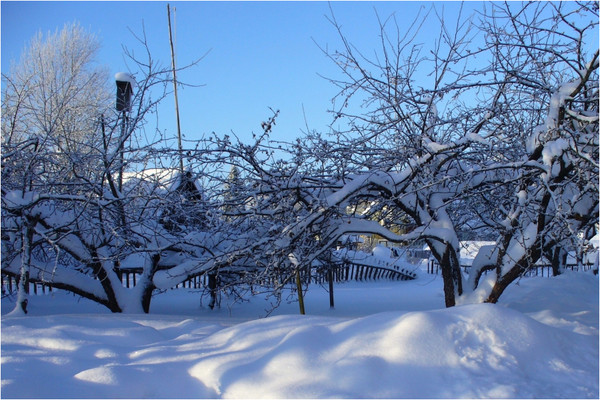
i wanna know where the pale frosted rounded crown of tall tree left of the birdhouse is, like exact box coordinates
[2,23,112,192]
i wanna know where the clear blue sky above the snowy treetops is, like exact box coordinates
[1,1,481,145]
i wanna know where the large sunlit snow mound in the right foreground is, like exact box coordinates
[189,304,598,398]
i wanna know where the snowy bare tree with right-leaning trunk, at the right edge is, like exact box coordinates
[469,3,599,302]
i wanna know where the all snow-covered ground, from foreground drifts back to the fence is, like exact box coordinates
[1,272,599,398]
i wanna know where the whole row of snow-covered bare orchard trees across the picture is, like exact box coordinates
[2,2,600,312]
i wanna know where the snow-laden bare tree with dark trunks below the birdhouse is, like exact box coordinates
[2,21,209,312]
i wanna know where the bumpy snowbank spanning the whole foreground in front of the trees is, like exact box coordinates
[2,304,598,398]
